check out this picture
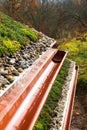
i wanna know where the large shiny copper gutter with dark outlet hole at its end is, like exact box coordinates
[0,47,67,130]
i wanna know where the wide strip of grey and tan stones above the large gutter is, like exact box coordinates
[0,33,56,94]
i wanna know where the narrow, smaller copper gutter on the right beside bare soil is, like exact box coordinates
[61,66,78,130]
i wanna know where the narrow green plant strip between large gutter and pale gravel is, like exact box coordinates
[34,60,70,130]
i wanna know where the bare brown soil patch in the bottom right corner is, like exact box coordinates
[70,94,87,130]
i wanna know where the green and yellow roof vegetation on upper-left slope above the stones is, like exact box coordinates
[0,12,38,55]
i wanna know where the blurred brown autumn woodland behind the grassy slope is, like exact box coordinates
[0,0,87,39]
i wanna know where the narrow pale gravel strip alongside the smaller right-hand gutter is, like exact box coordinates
[50,61,75,130]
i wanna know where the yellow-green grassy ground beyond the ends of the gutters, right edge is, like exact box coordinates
[59,34,87,93]
